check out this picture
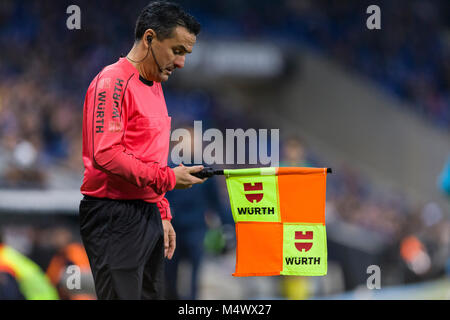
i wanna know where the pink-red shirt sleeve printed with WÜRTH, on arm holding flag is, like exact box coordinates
[92,73,175,194]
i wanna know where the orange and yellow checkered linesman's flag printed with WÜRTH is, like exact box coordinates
[224,167,327,276]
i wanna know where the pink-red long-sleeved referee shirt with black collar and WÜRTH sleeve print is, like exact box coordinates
[81,58,176,219]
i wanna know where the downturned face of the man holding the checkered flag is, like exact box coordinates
[151,26,197,82]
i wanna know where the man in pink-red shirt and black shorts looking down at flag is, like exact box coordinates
[80,2,204,299]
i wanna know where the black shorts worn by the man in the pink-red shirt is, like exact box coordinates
[80,196,164,300]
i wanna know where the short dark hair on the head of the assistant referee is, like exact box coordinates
[134,1,200,41]
